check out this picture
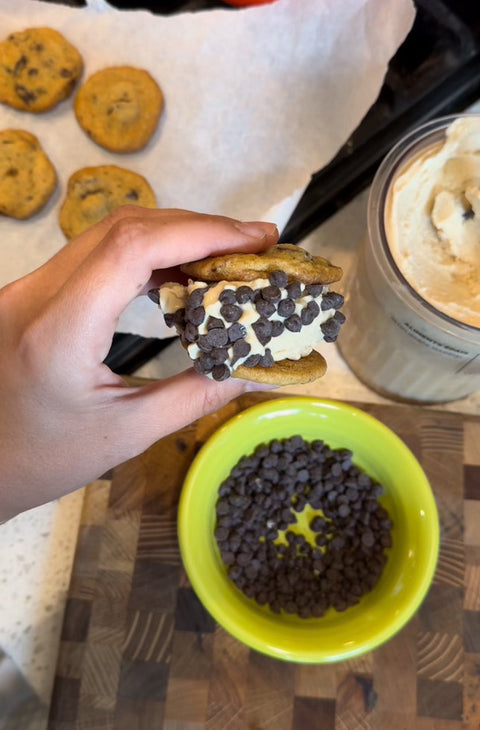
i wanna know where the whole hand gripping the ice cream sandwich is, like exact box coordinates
[0,207,278,521]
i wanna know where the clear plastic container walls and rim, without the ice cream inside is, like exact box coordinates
[338,115,480,403]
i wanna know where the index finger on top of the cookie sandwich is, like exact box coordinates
[51,211,278,346]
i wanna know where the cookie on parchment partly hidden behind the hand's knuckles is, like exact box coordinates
[59,165,157,239]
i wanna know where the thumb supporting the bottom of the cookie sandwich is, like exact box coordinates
[109,368,271,461]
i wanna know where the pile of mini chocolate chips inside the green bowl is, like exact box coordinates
[215,436,392,618]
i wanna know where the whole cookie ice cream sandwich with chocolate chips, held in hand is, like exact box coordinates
[158,244,345,385]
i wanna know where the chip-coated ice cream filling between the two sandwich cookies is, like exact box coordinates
[159,272,344,380]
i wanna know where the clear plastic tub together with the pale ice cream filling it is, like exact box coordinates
[338,114,480,403]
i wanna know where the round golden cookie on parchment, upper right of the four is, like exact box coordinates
[75,66,163,153]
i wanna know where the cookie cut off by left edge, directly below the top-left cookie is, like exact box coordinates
[0,129,57,218]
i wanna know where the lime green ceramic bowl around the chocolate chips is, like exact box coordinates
[178,397,439,663]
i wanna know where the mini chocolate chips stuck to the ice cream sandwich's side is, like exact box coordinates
[165,271,345,381]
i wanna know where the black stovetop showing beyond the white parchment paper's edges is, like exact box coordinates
[46,0,480,374]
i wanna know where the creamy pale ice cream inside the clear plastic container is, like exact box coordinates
[385,116,480,327]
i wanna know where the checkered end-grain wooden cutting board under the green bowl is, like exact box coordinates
[49,394,480,730]
